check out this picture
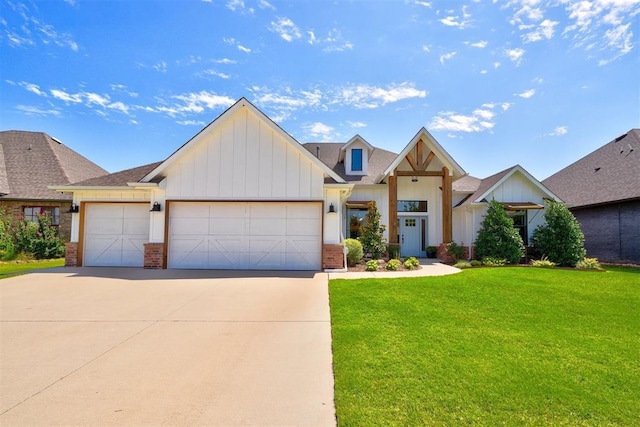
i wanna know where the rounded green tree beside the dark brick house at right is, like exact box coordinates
[532,200,586,267]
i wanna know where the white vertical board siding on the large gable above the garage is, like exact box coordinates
[166,109,324,200]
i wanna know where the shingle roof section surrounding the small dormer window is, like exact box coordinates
[302,142,398,185]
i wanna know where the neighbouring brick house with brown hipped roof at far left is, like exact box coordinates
[0,130,107,240]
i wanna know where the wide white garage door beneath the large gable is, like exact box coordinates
[168,202,322,270]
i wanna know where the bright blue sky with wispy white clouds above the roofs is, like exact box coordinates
[0,0,640,180]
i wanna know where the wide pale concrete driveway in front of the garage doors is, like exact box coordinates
[0,268,335,426]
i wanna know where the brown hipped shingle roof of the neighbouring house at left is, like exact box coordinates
[0,130,108,200]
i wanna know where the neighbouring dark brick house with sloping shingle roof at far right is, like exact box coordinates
[543,129,640,263]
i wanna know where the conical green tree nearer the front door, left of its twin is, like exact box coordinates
[476,200,524,264]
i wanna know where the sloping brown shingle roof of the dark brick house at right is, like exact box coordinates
[542,129,640,207]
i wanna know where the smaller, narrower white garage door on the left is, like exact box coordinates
[82,203,149,267]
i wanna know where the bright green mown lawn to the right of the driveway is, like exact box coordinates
[330,267,640,426]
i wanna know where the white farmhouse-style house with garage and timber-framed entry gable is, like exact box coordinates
[52,98,553,270]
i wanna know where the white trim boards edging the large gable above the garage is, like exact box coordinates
[140,98,344,186]
